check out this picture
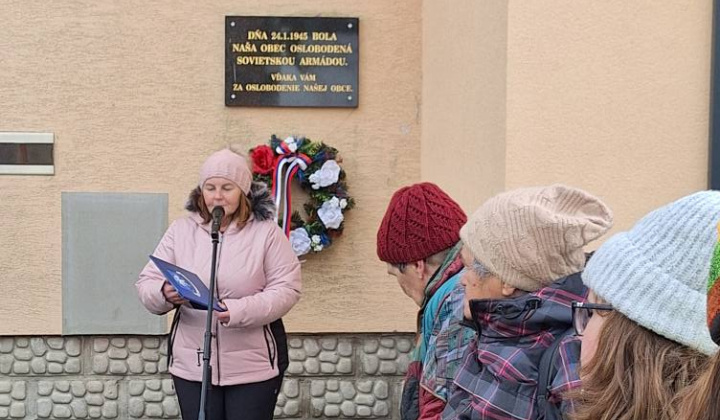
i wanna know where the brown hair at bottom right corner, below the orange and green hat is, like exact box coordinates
[676,353,720,420]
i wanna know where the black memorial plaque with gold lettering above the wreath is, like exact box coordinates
[225,16,359,108]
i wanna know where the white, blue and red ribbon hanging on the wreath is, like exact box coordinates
[272,148,312,237]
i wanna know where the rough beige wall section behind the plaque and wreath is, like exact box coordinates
[0,0,422,334]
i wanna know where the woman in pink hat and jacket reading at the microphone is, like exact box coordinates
[136,149,301,420]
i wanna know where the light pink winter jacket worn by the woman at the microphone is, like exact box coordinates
[135,205,301,386]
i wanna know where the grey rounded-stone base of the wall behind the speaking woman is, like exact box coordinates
[0,334,413,419]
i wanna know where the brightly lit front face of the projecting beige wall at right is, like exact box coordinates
[507,0,712,231]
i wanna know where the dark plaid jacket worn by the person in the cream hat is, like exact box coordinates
[442,273,587,420]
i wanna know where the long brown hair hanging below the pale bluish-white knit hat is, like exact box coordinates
[567,311,707,420]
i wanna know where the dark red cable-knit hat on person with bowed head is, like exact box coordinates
[377,182,467,264]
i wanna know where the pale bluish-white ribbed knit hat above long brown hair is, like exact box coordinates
[582,191,720,354]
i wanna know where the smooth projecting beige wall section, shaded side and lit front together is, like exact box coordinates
[422,0,712,236]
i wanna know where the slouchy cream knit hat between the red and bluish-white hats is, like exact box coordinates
[460,184,613,292]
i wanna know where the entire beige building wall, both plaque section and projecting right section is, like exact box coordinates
[0,0,712,334]
